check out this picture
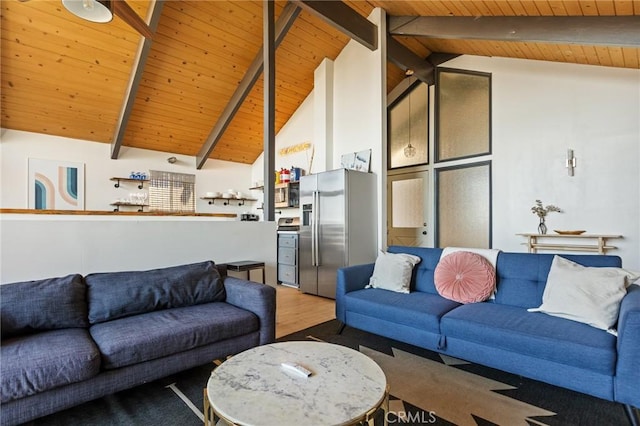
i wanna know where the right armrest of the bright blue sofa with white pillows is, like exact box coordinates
[615,285,640,407]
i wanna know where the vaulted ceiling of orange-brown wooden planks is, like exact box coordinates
[1,0,640,163]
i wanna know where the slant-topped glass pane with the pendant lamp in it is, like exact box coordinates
[388,83,429,169]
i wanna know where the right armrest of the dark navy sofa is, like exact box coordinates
[224,276,276,345]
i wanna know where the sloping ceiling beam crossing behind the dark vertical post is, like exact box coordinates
[196,3,300,169]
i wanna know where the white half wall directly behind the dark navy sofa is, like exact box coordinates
[0,214,276,285]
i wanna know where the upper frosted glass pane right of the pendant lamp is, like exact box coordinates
[435,68,491,162]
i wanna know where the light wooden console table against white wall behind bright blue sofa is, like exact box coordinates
[516,234,622,254]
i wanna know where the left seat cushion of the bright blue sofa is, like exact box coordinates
[344,288,460,333]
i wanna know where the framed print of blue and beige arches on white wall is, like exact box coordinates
[29,158,84,210]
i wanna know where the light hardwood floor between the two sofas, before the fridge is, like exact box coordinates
[276,285,336,338]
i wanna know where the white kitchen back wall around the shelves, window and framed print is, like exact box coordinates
[0,129,252,213]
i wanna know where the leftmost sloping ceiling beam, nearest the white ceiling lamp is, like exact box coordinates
[111,0,164,160]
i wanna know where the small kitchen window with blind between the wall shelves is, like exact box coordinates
[149,170,196,213]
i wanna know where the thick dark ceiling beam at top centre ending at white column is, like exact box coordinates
[293,0,378,51]
